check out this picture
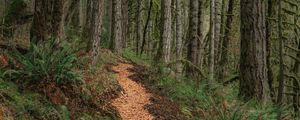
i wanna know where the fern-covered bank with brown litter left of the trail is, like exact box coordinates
[0,41,120,120]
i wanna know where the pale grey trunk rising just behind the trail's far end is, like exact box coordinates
[111,0,122,53]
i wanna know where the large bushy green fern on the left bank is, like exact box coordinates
[8,40,82,84]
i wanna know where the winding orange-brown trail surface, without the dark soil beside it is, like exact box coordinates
[112,63,154,120]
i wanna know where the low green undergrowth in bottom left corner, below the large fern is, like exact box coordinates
[0,80,69,120]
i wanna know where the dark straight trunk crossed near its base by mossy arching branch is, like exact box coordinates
[187,0,199,79]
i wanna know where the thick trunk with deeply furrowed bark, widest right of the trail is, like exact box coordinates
[239,0,269,102]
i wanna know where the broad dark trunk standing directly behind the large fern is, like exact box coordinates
[31,0,65,43]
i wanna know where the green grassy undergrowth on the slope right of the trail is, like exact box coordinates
[124,51,291,120]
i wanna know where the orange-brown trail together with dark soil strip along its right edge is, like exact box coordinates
[112,63,182,120]
